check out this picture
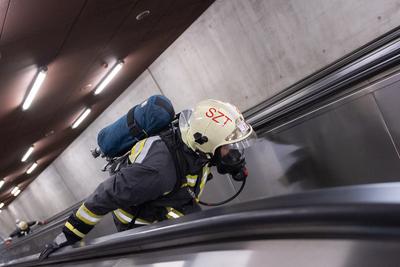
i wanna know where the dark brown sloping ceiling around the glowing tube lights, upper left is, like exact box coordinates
[0,0,213,205]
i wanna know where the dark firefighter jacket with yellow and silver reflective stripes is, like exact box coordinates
[63,130,210,242]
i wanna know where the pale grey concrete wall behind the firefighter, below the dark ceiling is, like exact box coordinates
[0,0,400,239]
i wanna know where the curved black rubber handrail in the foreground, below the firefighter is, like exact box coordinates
[3,183,400,266]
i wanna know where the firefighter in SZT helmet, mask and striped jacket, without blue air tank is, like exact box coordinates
[40,99,254,259]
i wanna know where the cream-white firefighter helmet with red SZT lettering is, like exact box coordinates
[179,99,254,156]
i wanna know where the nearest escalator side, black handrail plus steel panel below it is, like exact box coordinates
[1,183,400,267]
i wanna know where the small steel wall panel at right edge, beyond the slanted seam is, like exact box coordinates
[374,79,400,154]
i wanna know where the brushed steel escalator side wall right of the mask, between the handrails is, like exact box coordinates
[195,74,400,205]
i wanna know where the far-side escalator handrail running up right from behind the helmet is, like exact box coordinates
[244,27,400,129]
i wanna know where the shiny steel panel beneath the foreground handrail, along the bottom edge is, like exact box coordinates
[56,239,400,267]
